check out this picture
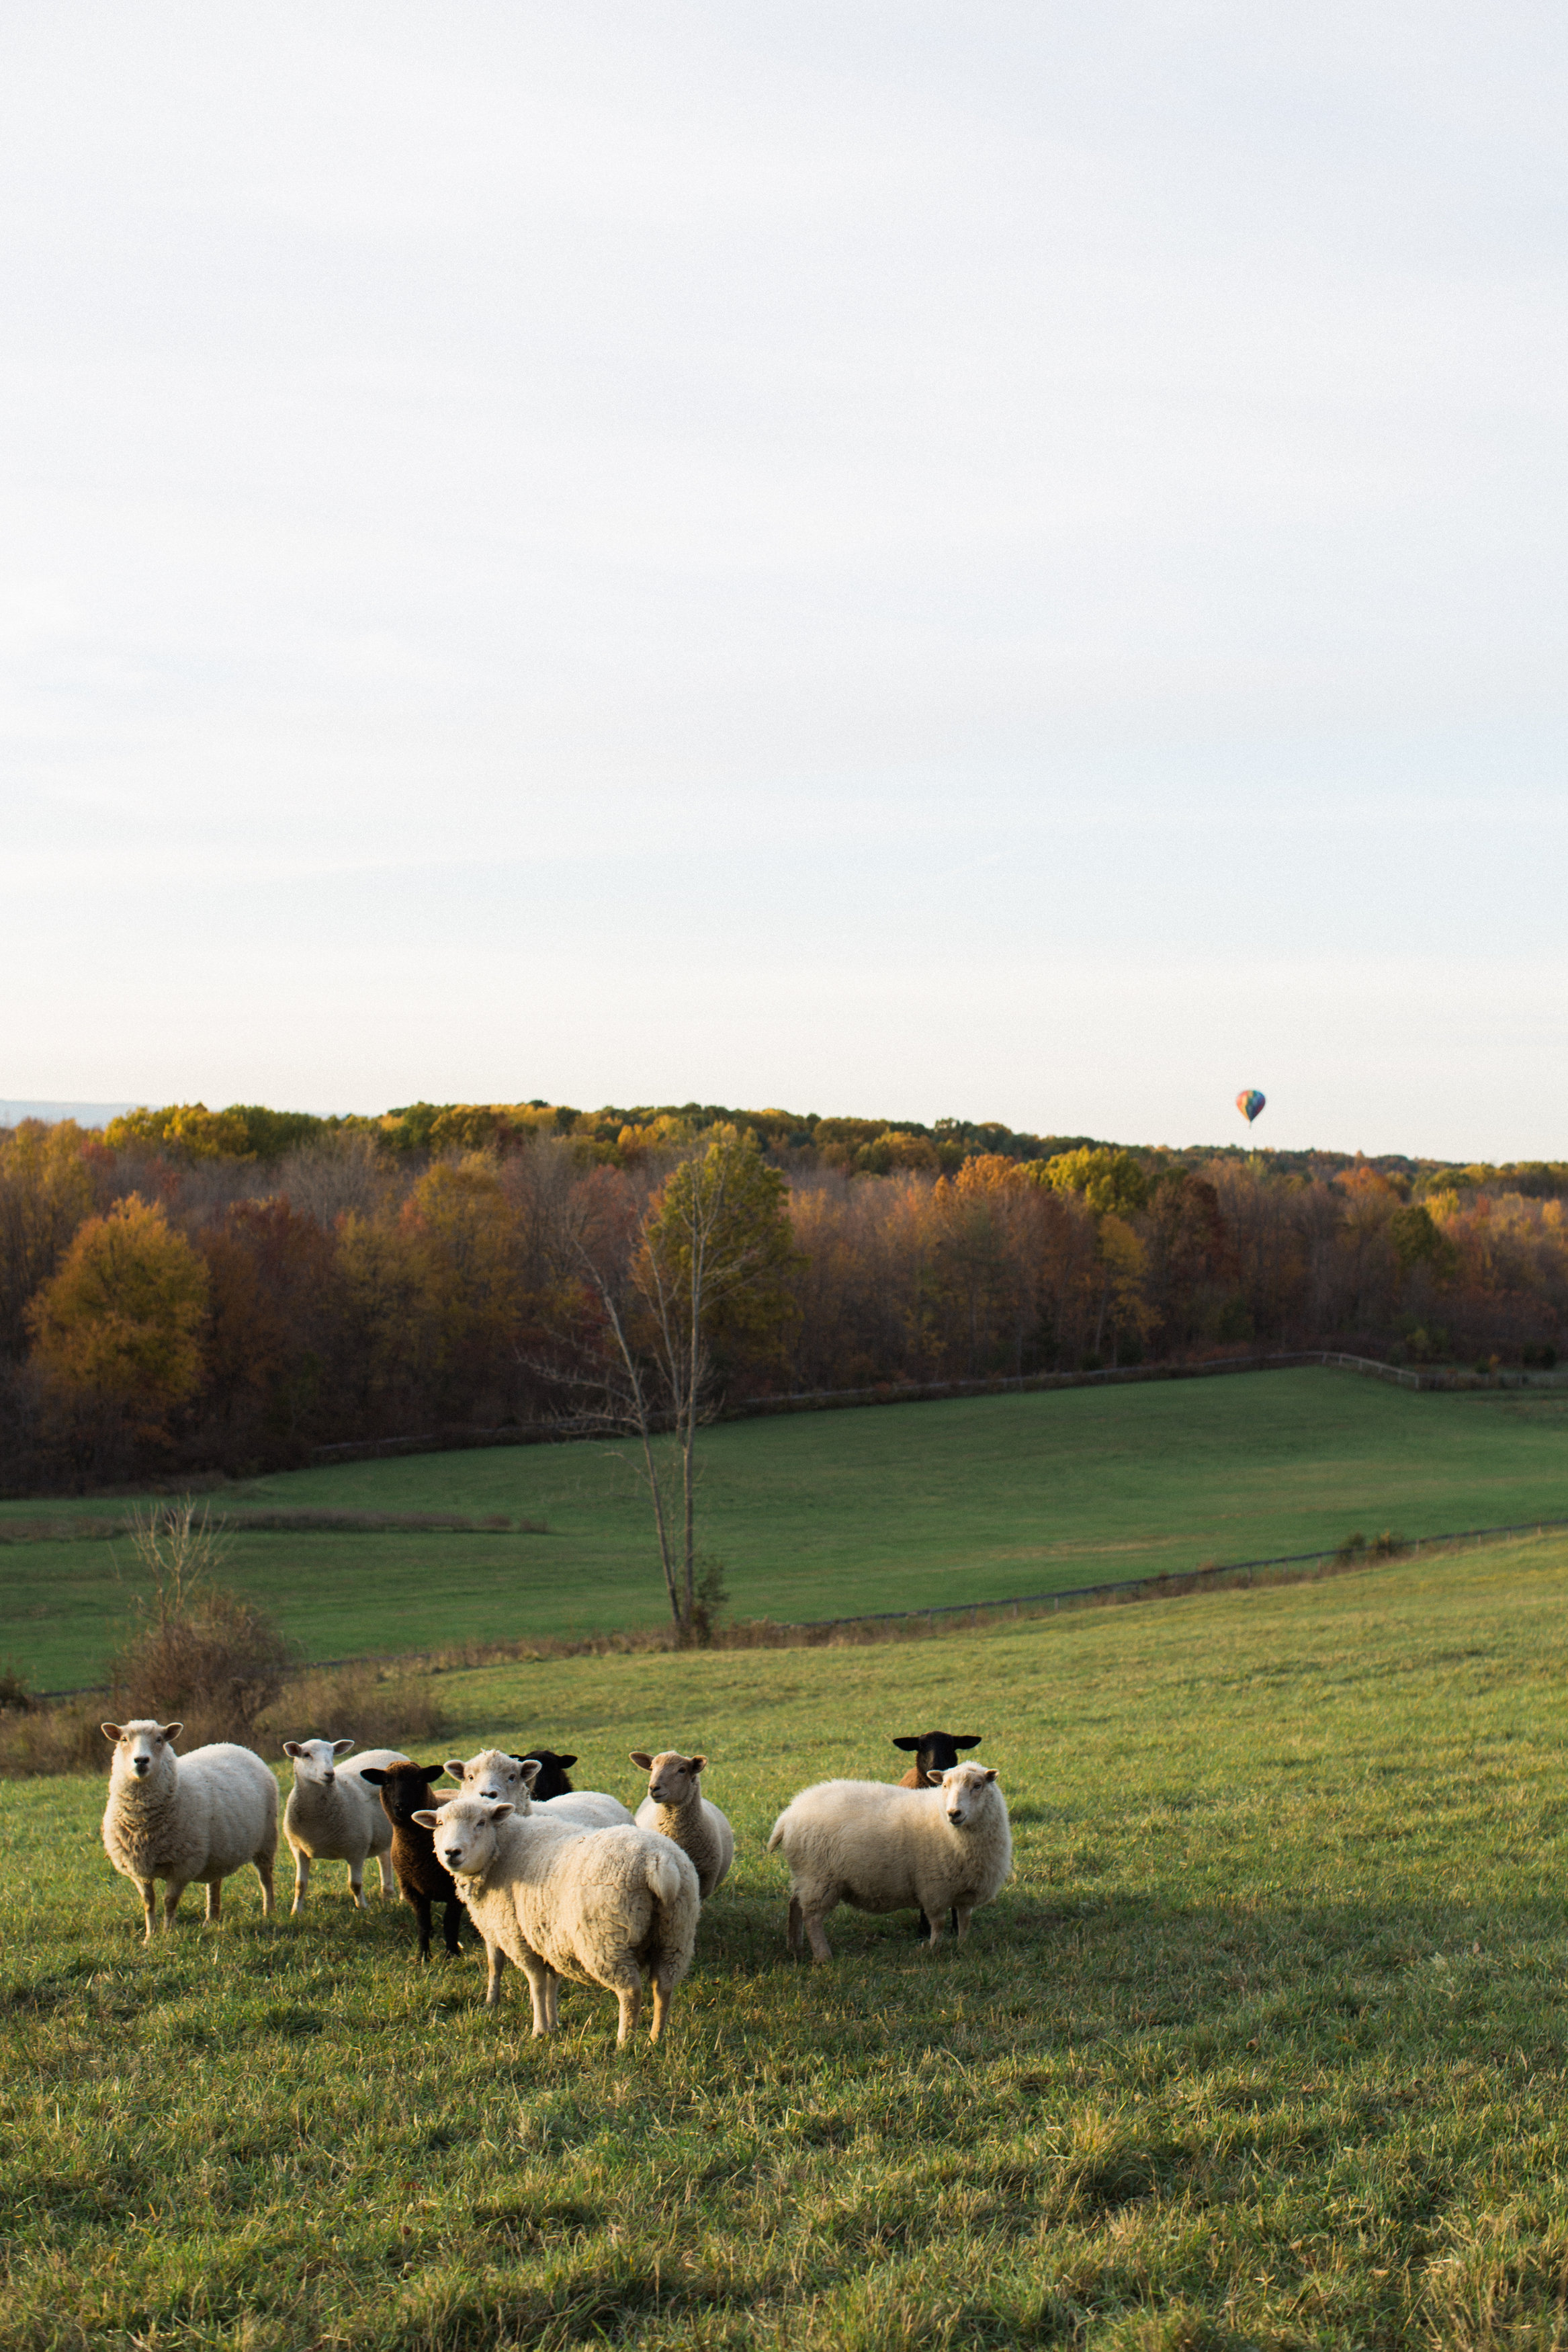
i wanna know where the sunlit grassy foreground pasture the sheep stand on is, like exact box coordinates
[0,1538,1568,2352]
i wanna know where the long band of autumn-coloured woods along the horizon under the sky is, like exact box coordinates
[0,1103,1568,1494]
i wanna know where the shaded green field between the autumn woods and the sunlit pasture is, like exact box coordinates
[0,1372,1568,1689]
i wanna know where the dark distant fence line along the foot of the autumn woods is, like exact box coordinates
[310,1348,1568,1463]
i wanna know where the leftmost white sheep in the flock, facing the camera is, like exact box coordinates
[101,1717,277,1943]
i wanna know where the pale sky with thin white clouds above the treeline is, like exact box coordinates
[0,0,1568,1160]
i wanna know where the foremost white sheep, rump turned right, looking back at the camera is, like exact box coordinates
[414,1797,701,2046]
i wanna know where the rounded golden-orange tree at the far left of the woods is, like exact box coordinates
[28,1193,207,1439]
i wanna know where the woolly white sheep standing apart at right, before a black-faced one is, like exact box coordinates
[769,1764,1013,1960]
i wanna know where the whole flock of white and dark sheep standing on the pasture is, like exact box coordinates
[103,1717,1013,2042]
